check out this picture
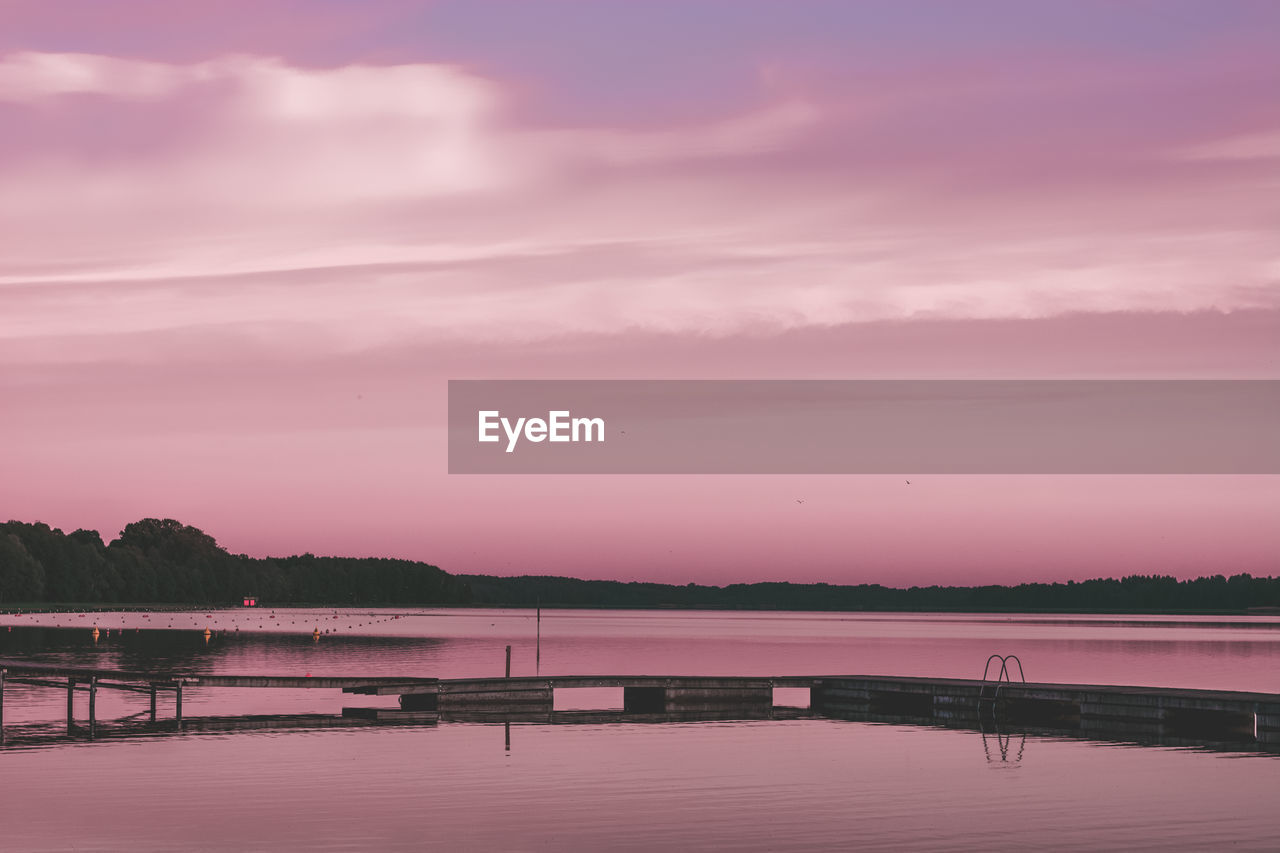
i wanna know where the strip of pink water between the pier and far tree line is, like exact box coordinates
[0,610,1280,693]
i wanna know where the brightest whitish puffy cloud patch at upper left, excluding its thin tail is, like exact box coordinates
[0,54,517,209]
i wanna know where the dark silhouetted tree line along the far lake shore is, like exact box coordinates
[0,519,1280,612]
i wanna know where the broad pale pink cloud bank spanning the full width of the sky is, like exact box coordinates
[0,53,1280,352]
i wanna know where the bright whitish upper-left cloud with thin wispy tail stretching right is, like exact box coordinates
[0,53,814,206]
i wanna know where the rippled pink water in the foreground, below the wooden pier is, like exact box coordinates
[0,720,1280,853]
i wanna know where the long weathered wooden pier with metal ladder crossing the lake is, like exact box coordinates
[0,661,1280,751]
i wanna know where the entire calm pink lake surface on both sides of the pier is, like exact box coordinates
[0,610,1280,850]
